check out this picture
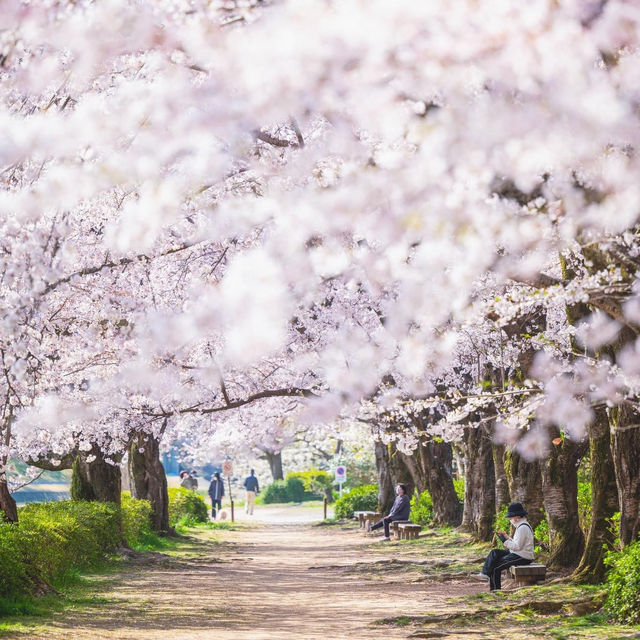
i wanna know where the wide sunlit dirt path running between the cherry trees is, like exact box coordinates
[13,514,481,640]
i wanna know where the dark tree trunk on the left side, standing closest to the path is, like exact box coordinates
[129,433,171,535]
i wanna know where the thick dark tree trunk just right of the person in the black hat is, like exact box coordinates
[540,426,587,568]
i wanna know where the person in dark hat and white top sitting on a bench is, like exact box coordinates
[475,502,534,591]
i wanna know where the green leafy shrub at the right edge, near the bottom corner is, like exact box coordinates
[605,541,640,624]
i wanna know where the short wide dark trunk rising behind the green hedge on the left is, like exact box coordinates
[71,445,121,506]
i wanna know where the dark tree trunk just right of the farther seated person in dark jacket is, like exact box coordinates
[412,440,462,527]
